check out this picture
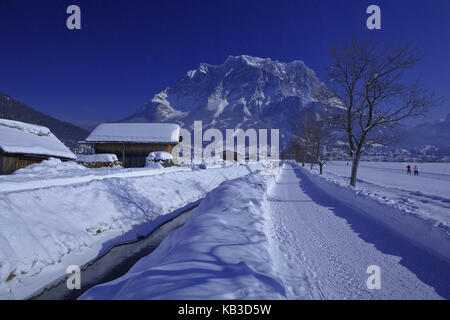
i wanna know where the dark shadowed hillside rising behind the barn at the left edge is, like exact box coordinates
[0,92,88,150]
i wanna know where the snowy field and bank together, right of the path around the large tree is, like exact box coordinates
[314,162,450,260]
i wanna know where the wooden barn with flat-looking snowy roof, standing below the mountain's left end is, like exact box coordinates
[84,123,181,168]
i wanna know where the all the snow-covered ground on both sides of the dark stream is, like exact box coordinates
[0,160,450,299]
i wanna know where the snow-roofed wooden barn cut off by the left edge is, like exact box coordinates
[0,119,76,174]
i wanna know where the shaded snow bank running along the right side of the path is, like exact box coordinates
[298,165,450,261]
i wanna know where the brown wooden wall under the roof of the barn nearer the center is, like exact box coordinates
[95,143,173,168]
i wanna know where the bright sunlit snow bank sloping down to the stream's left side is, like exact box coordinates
[0,165,259,298]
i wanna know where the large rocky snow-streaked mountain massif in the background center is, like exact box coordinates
[123,55,325,141]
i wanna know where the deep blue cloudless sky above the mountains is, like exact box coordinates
[0,0,450,122]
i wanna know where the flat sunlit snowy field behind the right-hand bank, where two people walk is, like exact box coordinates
[314,161,450,233]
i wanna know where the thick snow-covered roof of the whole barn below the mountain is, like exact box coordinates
[86,123,181,143]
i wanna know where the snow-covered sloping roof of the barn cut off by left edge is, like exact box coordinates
[0,119,76,159]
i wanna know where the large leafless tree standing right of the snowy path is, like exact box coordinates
[318,40,440,186]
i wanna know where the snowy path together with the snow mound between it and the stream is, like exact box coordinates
[81,164,450,299]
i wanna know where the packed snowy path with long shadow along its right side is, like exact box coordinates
[268,165,450,299]
